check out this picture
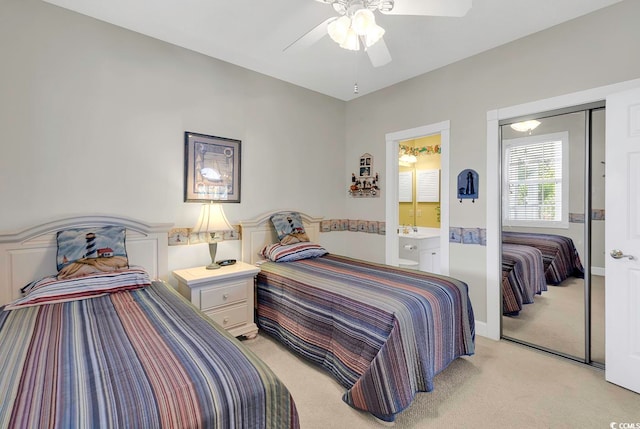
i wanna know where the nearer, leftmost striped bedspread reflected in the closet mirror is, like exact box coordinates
[502,243,547,315]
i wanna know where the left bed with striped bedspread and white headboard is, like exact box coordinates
[0,216,299,429]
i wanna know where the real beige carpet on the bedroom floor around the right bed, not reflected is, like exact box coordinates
[243,333,640,429]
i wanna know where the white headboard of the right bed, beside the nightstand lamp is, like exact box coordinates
[240,210,322,264]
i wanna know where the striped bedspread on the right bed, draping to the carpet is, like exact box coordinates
[257,255,474,421]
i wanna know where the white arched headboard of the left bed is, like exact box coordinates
[0,215,172,305]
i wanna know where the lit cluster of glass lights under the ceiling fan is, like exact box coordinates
[317,0,394,51]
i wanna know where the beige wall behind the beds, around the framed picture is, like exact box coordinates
[0,0,347,267]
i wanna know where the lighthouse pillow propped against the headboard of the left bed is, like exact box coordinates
[56,226,129,279]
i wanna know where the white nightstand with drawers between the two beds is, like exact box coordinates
[173,262,260,338]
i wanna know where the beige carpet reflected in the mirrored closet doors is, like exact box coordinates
[502,276,605,363]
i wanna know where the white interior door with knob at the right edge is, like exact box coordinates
[605,88,640,392]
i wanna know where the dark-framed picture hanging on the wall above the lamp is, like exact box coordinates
[184,131,242,203]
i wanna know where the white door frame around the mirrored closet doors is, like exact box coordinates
[486,79,640,340]
